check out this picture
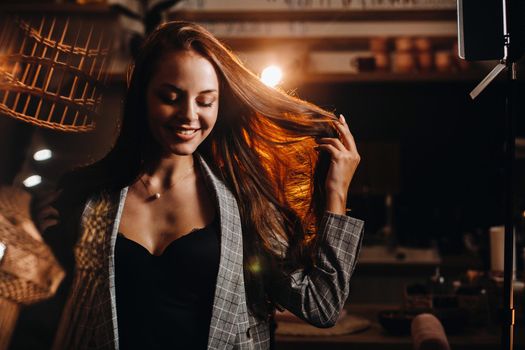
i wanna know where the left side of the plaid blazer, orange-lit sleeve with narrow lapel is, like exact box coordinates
[53,189,126,350]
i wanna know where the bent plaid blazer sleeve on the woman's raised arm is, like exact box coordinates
[271,211,364,328]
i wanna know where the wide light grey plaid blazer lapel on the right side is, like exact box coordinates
[196,153,248,349]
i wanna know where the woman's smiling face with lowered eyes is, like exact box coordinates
[147,51,219,155]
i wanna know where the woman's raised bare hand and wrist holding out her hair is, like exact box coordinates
[316,114,361,214]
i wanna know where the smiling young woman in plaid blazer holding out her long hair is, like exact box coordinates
[50,22,363,349]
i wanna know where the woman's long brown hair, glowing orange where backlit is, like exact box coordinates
[67,21,337,318]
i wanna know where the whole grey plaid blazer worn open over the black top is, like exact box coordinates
[53,153,363,350]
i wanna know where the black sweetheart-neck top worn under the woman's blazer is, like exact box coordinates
[115,218,220,350]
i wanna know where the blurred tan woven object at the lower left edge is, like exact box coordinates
[0,186,64,350]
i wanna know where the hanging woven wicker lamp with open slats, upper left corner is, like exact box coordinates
[0,15,114,132]
